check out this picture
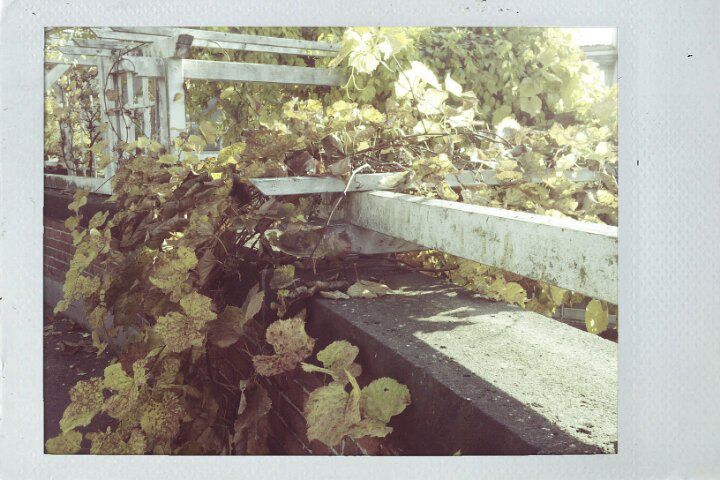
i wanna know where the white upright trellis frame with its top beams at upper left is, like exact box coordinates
[45,27,345,193]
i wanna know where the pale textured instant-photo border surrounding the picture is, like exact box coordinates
[0,0,720,480]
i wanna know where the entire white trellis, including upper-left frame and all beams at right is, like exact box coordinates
[46,27,618,304]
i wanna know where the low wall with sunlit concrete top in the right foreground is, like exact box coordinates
[308,270,617,455]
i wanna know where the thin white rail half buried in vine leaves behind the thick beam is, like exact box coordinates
[250,169,598,196]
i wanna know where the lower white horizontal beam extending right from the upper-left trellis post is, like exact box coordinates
[183,59,346,86]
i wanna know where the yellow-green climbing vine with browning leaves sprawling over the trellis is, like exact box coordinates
[46,25,617,454]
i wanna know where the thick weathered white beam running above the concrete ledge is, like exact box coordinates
[346,191,618,304]
